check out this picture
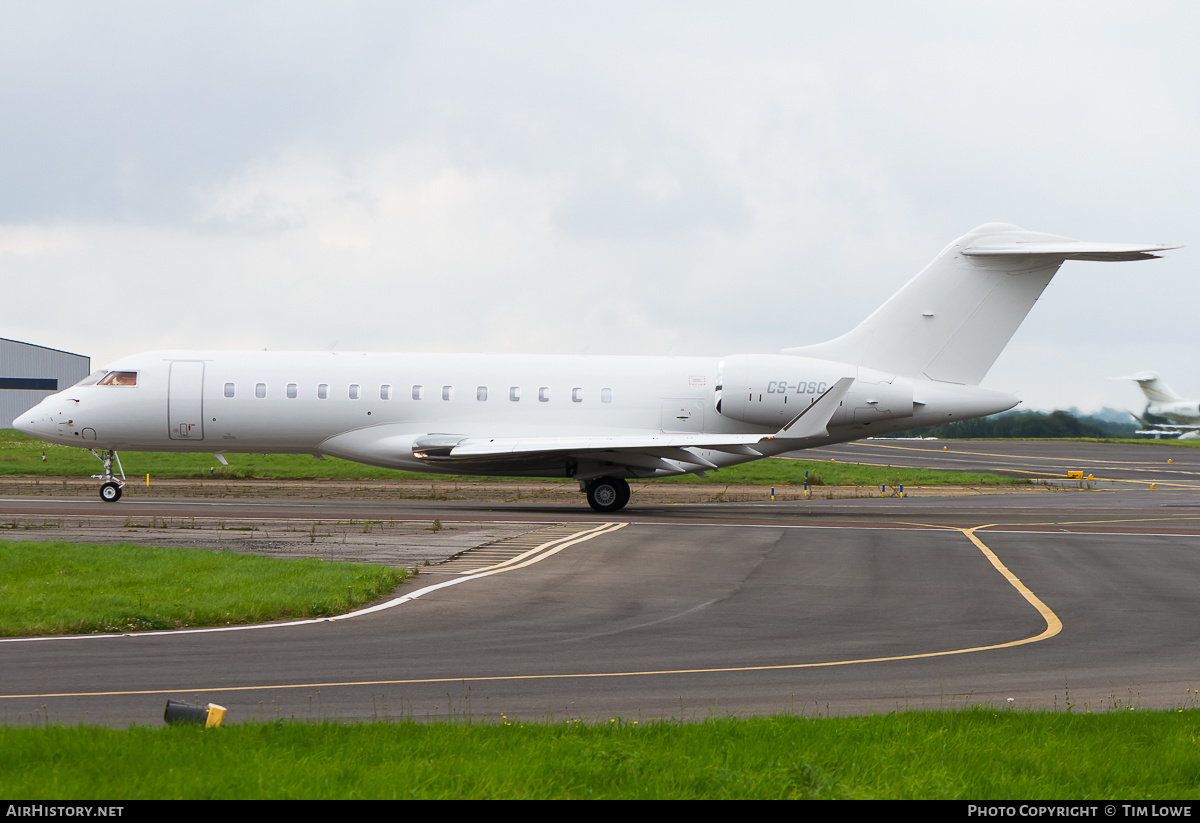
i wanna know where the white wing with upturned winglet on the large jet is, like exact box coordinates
[413,377,854,473]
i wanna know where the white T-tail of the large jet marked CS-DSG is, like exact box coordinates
[784,223,1176,385]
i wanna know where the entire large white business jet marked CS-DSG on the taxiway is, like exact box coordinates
[13,223,1175,511]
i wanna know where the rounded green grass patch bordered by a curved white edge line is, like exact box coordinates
[0,542,410,637]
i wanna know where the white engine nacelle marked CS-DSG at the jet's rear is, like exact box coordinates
[715,354,913,427]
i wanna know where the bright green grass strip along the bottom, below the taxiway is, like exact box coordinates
[0,707,1200,801]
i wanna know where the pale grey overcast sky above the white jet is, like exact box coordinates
[0,0,1200,409]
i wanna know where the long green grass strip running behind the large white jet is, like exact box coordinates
[0,429,1028,486]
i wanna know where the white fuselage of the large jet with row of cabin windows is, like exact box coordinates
[14,352,1016,476]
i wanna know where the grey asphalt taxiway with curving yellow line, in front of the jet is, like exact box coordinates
[0,441,1200,725]
